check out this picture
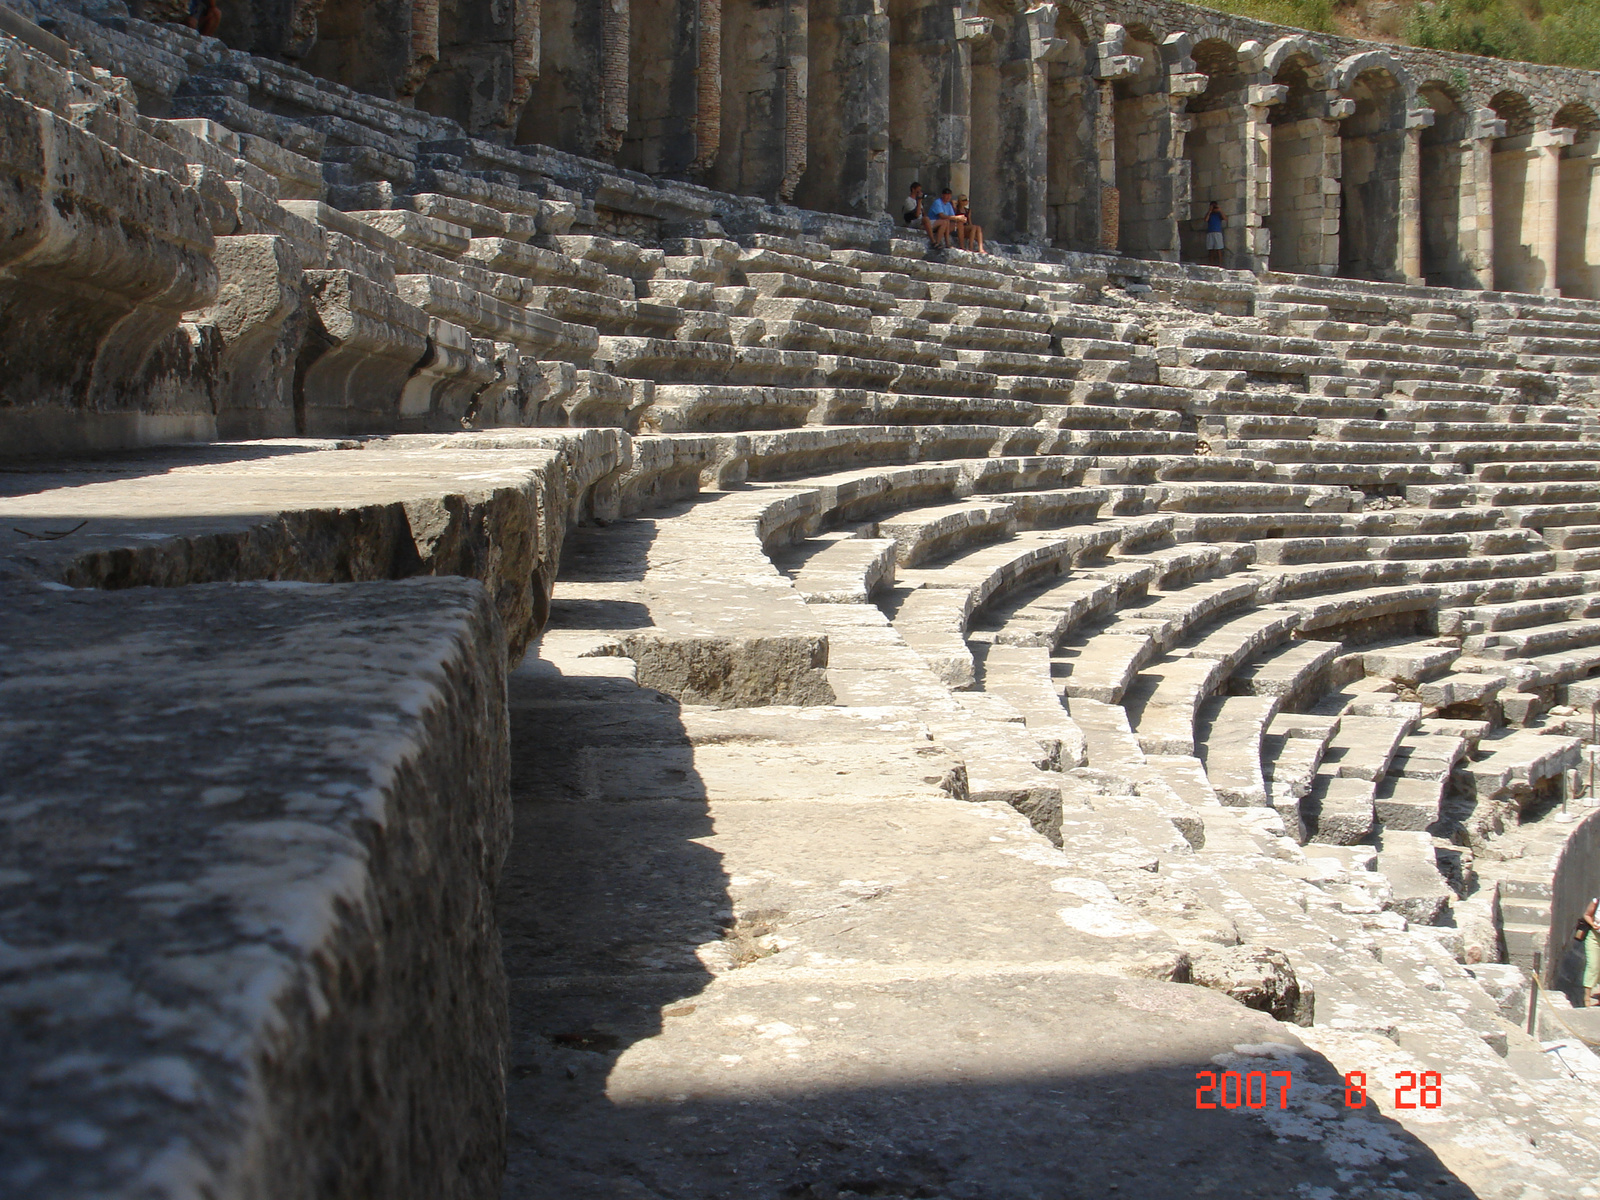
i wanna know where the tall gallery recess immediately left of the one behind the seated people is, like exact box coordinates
[795,0,890,216]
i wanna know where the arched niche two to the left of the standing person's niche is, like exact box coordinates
[1045,3,1101,250]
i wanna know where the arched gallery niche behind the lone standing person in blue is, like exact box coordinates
[1178,38,1250,262]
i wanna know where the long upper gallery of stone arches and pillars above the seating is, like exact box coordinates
[203,0,1600,299]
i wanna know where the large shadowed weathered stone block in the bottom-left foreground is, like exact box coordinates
[0,579,510,1200]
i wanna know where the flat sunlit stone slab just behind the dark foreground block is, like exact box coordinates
[0,430,621,658]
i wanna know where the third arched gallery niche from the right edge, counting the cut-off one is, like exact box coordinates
[1418,80,1478,288]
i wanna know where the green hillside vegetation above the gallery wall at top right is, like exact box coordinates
[1211,0,1600,70]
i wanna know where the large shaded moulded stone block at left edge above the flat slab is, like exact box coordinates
[0,80,216,451]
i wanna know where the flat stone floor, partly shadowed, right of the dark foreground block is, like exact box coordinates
[501,659,1484,1200]
